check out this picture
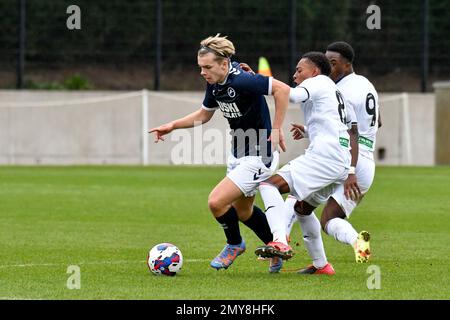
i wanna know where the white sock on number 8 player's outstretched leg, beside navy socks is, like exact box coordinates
[259,183,288,244]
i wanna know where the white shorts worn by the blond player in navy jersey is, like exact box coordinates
[227,151,280,197]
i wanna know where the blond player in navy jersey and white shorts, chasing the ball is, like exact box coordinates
[149,34,290,270]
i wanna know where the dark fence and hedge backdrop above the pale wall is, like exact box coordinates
[0,0,450,92]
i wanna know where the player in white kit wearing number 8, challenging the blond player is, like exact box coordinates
[255,52,358,274]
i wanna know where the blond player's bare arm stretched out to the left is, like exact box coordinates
[148,108,214,143]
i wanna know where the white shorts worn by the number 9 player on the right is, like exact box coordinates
[332,153,375,218]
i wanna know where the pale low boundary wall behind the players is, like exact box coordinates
[0,90,435,165]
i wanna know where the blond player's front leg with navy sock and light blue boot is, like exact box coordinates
[208,177,245,270]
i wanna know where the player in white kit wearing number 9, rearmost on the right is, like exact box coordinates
[286,42,381,263]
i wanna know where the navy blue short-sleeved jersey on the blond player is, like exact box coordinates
[203,62,272,164]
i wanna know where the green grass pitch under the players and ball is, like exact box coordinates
[0,166,450,300]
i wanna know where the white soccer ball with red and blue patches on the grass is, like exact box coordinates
[147,243,183,276]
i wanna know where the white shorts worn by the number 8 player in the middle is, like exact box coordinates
[276,153,348,207]
